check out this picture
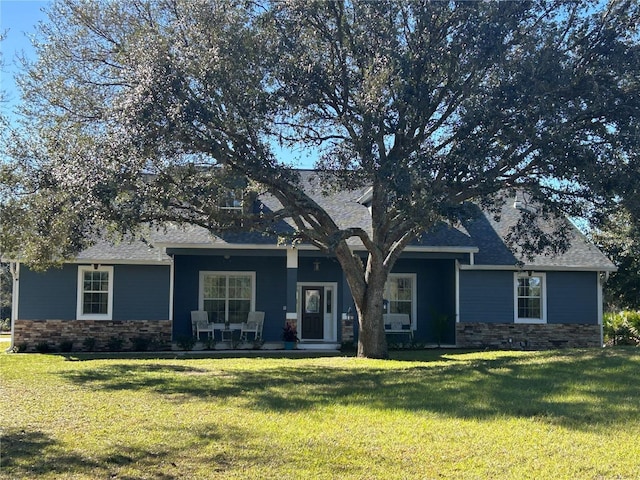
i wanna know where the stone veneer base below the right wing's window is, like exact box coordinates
[456,322,602,350]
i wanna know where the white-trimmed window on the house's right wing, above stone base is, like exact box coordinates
[514,273,547,323]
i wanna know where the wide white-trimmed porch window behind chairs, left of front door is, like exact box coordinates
[199,272,255,323]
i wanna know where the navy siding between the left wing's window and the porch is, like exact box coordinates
[113,265,170,320]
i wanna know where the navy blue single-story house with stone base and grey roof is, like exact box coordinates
[6,171,615,350]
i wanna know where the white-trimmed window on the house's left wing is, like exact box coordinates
[76,265,113,320]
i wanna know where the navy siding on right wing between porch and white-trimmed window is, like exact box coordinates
[460,270,514,323]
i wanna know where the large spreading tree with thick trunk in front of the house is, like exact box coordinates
[0,0,640,357]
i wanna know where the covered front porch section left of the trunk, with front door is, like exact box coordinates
[167,245,354,350]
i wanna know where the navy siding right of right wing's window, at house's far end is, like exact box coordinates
[547,272,598,325]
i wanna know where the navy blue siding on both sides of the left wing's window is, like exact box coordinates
[18,264,170,320]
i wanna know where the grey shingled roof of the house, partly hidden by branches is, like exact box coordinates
[72,170,615,271]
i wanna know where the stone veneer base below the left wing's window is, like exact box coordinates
[13,320,172,352]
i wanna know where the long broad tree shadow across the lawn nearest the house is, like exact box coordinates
[57,350,640,429]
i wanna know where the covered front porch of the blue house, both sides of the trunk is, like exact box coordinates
[166,244,457,351]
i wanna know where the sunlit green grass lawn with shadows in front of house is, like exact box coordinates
[0,349,640,480]
